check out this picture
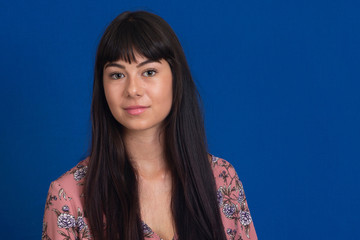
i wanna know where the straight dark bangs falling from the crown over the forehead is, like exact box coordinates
[98,18,174,67]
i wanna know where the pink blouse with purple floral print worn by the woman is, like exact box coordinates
[42,155,257,240]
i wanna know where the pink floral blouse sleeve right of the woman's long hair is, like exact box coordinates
[213,159,257,240]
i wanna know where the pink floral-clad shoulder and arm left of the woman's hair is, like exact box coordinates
[42,158,90,240]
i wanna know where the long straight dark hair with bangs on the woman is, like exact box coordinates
[85,11,225,240]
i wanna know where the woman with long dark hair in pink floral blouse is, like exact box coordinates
[42,11,257,240]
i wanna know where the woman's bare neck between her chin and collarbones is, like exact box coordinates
[124,128,168,180]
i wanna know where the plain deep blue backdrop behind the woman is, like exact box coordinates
[0,0,360,240]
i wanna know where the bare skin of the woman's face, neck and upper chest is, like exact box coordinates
[103,54,174,240]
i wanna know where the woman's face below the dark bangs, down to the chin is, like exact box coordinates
[103,54,172,134]
